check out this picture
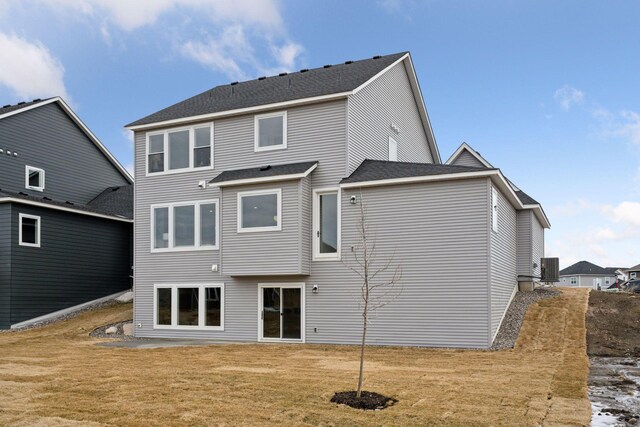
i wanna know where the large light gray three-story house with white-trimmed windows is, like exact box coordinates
[127,53,549,348]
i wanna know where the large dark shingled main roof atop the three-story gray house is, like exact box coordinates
[127,52,407,126]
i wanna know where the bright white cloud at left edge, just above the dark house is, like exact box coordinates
[0,33,70,101]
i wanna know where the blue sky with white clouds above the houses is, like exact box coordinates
[0,0,640,267]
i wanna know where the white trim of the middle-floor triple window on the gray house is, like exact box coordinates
[150,199,220,253]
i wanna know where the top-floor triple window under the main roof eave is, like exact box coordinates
[147,124,213,175]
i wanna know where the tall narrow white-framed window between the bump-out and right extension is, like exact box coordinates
[313,189,340,260]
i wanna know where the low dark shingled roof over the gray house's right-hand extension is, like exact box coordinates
[340,159,496,184]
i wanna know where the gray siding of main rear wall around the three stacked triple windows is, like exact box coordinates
[134,100,347,341]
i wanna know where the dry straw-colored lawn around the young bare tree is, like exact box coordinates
[0,289,591,426]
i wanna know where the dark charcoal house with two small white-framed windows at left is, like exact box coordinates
[0,98,133,329]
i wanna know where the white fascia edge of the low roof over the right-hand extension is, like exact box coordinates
[340,169,551,228]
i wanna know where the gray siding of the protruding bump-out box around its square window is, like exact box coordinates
[222,180,311,276]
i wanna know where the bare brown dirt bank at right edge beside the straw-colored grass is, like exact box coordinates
[587,291,640,357]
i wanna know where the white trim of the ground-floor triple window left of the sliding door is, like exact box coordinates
[153,283,226,331]
